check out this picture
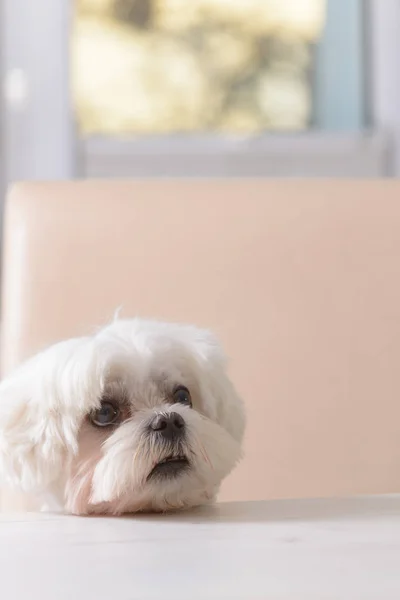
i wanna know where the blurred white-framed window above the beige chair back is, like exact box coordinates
[1,0,400,180]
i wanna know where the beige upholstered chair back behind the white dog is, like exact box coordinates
[1,180,400,500]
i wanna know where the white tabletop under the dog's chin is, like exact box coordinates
[0,496,400,600]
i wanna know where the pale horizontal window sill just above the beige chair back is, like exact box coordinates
[79,132,390,178]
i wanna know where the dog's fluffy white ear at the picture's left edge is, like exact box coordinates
[0,338,100,491]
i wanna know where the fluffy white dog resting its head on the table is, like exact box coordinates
[0,319,244,514]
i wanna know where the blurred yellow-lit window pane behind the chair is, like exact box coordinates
[72,0,325,135]
